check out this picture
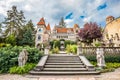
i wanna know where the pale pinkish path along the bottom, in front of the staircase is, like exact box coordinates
[0,68,120,80]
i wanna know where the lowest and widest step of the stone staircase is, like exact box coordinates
[30,71,100,75]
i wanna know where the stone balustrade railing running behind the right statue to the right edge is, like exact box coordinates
[78,47,120,55]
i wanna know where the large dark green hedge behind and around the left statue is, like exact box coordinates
[0,46,43,73]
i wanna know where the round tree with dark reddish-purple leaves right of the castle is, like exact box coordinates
[78,22,102,43]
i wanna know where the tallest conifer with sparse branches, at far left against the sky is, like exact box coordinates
[3,6,25,37]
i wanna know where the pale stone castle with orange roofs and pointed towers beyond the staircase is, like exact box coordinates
[35,18,79,47]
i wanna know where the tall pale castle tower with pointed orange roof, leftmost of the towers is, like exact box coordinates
[35,18,46,47]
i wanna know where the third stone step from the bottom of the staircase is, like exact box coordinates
[45,65,85,68]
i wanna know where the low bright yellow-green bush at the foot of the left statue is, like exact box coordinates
[9,63,36,74]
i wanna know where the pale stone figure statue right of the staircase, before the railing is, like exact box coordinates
[96,48,106,68]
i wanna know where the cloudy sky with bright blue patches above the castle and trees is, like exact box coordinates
[0,0,120,27]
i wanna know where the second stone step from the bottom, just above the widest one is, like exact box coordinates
[43,68,87,71]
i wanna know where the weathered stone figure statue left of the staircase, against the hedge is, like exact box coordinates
[18,49,28,66]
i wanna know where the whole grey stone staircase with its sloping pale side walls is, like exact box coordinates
[29,54,99,75]
